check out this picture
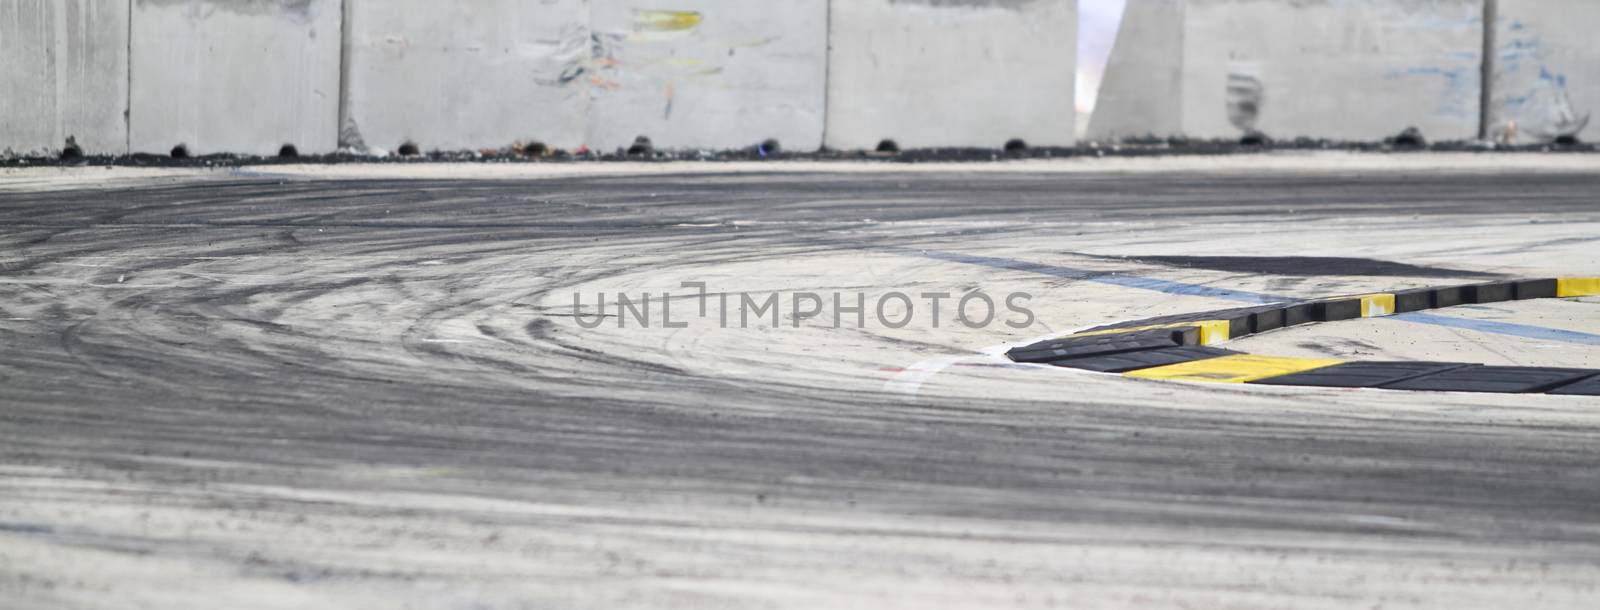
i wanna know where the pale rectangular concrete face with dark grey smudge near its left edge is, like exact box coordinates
[1182,0,1483,141]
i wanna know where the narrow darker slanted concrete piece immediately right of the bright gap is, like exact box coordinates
[1086,0,1184,141]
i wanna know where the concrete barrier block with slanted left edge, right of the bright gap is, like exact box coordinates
[1090,0,1483,141]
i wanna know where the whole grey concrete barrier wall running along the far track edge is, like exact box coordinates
[9,0,1600,155]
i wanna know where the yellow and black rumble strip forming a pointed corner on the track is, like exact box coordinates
[1006,277,1600,395]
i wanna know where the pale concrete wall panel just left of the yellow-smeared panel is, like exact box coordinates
[342,0,594,150]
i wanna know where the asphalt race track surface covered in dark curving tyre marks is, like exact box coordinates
[0,161,1600,610]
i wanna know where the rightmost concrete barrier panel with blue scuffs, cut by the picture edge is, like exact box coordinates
[1490,0,1600,142]
